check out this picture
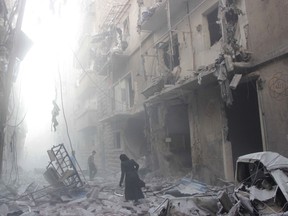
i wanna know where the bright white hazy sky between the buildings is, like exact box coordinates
[18,0,80,170]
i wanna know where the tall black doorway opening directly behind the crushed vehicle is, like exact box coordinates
[226,80,263,166]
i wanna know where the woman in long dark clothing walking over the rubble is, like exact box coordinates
[119,154,145,202]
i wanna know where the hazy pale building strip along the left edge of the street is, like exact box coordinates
[0,0,32,179]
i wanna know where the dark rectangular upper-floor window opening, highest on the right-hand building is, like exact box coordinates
[207,6,222,46]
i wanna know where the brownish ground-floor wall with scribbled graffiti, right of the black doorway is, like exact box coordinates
[257,57,288,157]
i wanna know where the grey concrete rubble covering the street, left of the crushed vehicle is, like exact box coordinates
[0,170,223,216]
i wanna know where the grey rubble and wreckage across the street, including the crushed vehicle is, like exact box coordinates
[0,152,288,216]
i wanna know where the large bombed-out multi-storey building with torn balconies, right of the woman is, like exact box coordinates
[75,0,288,184]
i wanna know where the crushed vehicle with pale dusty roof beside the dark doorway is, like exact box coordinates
[233,152,288,215]
